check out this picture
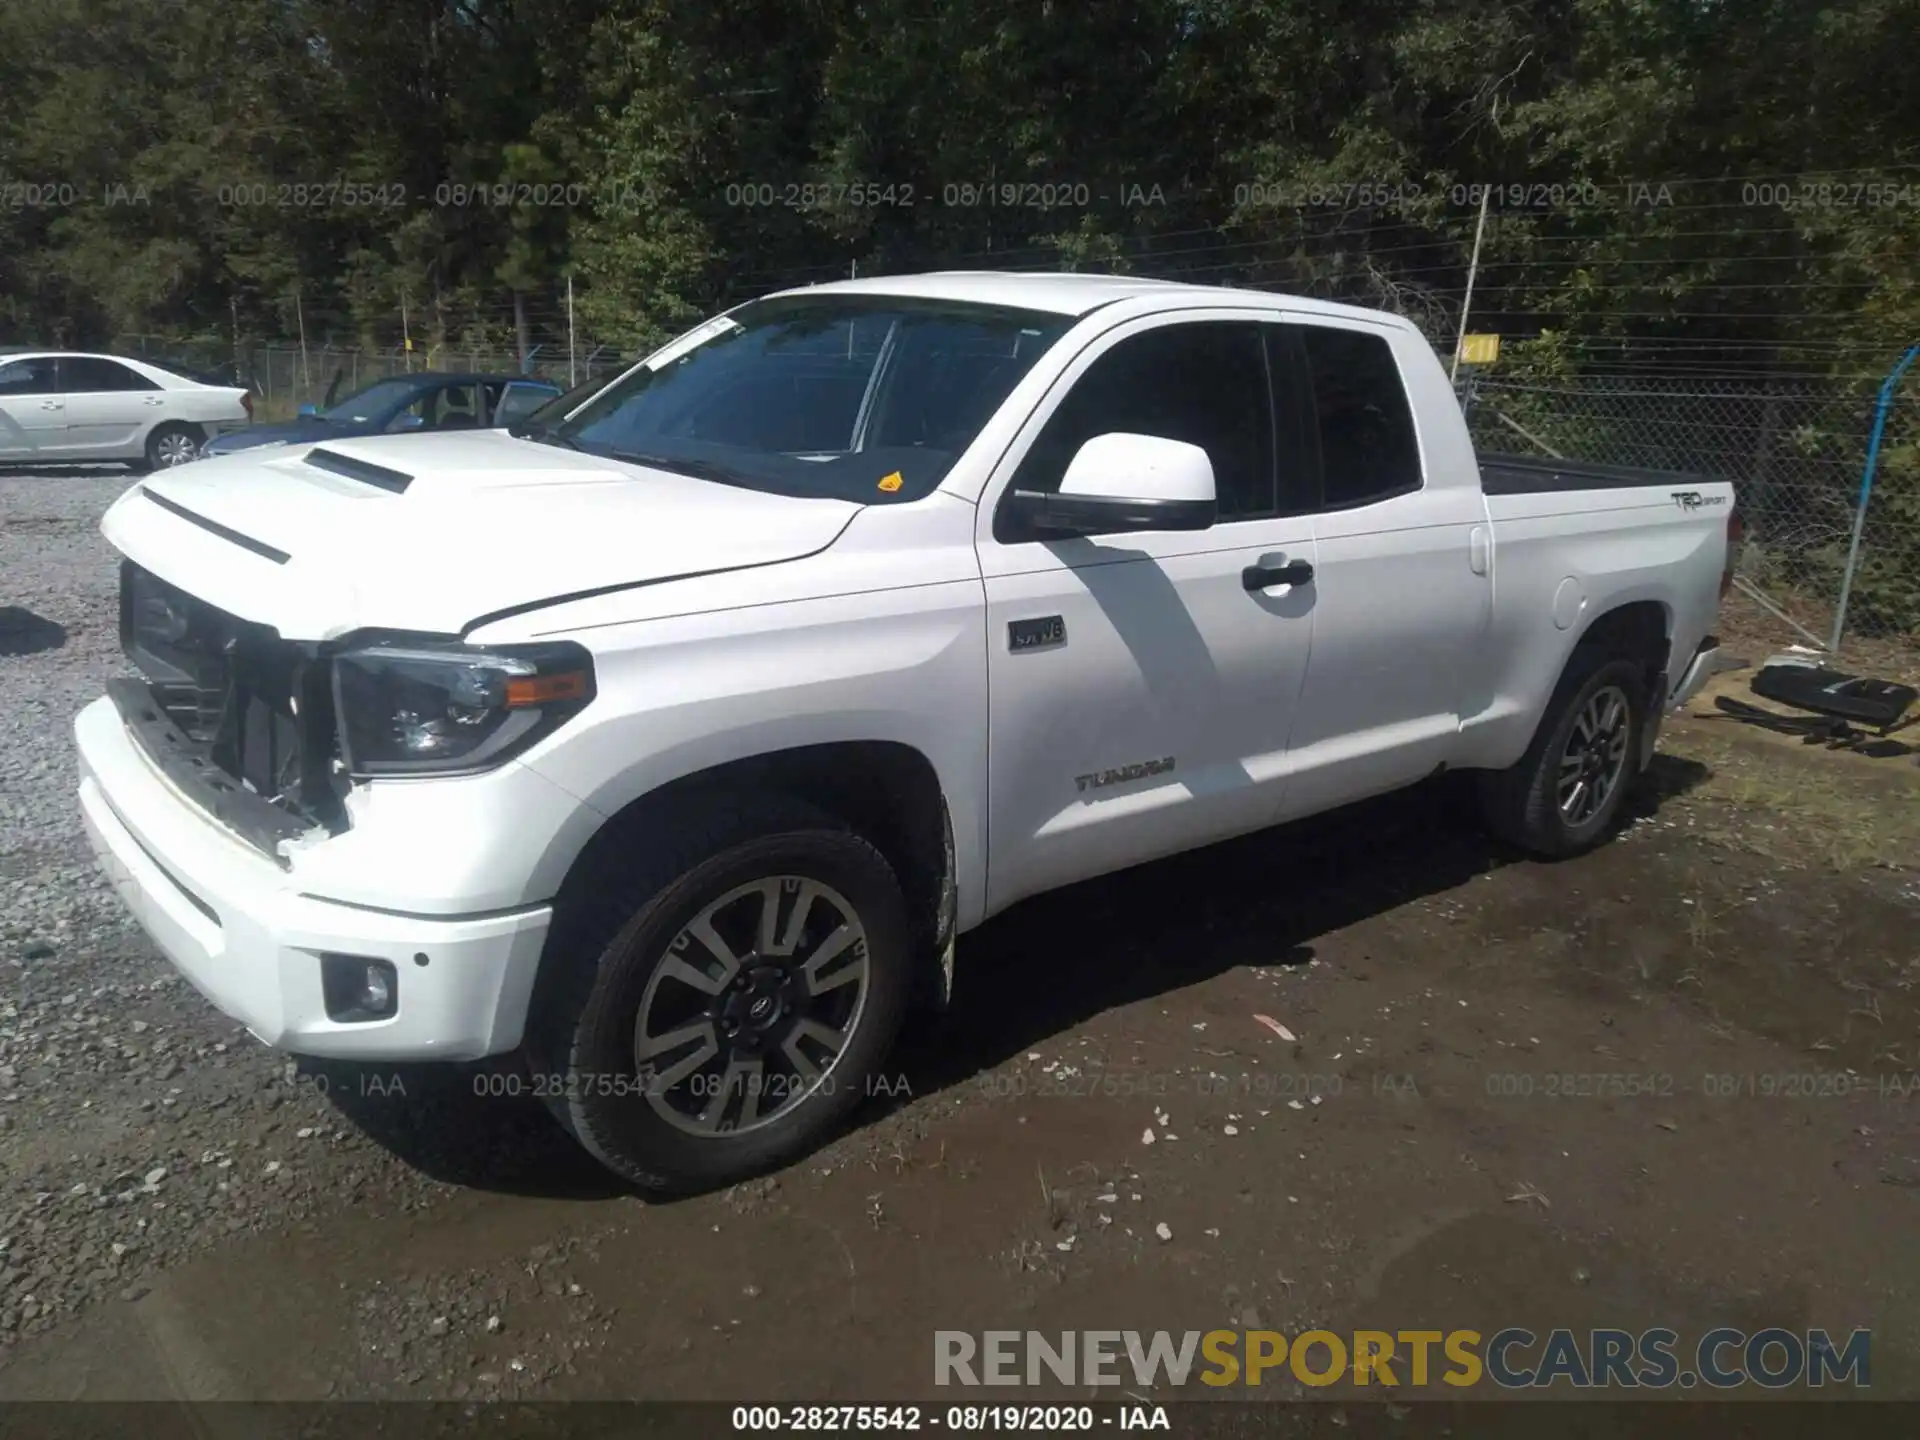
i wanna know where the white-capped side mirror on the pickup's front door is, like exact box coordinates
[1012,430,1219,536]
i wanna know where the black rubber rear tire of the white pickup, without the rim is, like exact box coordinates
[1480,647,1647,858]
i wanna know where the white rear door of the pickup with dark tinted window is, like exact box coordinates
[1271,317,1492,829]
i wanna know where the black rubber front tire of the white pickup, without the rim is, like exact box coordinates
[524,797,914,1192]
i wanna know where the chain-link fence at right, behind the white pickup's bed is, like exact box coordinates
[1463,372,1920,645]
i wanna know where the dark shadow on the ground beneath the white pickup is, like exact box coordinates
[311,755,1711,1200]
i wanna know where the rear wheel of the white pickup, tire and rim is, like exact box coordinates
[1480,651,1647,858]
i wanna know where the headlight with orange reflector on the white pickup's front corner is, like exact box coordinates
[334,641,593,778]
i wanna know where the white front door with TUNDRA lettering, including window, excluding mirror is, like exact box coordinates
[977,311,1315,912]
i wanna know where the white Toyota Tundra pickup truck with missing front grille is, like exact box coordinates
[75,273,1734,1188]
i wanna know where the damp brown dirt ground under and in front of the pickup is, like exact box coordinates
[0,683,1920,1402]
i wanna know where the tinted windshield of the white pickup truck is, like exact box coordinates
[549,296,1073,503]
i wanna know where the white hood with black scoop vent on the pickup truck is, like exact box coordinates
[102,430,860,641]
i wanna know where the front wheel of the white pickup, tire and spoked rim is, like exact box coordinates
[528,801,914,1190]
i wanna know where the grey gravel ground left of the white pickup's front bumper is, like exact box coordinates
[0,480,483,1344]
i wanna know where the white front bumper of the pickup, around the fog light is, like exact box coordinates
[73,699,553,1062]
